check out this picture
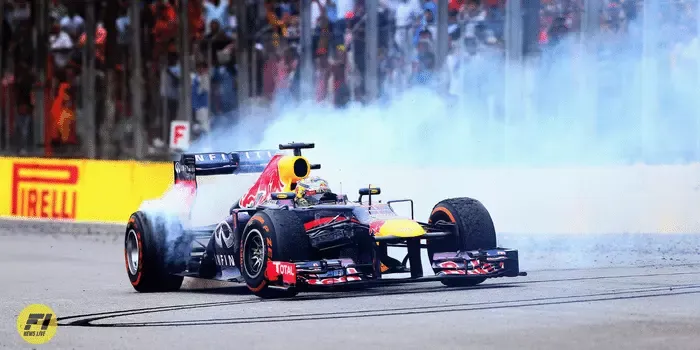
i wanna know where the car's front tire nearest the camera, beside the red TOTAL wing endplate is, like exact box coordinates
[239,210,311,298]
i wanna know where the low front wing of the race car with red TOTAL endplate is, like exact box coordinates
[265,248,526,289]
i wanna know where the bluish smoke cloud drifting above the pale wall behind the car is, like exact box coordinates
[193,1,700,170]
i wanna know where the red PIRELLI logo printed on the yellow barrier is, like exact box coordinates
[12,163,79,219]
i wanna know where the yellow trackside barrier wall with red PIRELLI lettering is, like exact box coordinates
[0,158,173,223]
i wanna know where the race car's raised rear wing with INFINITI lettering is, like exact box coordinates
[173,150,279,184]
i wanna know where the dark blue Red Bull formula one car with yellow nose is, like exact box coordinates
[124,143,525,297]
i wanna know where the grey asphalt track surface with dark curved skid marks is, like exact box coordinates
[0,231,700,350]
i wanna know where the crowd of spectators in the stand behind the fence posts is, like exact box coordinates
[1,0,682,158]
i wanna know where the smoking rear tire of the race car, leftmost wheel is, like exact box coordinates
[124,211,191,293]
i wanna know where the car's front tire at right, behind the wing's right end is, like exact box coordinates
[427,197,497,286]
